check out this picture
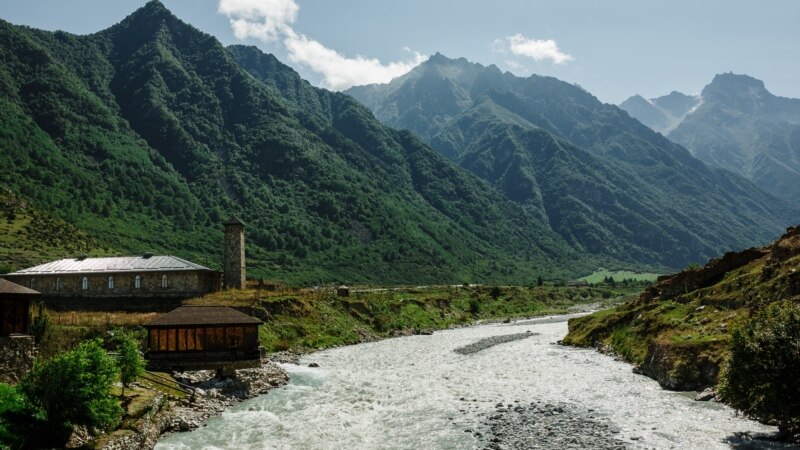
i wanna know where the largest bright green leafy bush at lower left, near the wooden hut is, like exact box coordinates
[20,339,122,443]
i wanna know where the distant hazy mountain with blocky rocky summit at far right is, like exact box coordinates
[667,73,800,205]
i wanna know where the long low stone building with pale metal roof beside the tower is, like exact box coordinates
[4,254,222,299]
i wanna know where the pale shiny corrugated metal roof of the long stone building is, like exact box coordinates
[9,256,211,275]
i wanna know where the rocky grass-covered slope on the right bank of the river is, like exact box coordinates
[564,227,800,390]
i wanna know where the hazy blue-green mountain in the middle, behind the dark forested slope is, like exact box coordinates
[348,54,798,267]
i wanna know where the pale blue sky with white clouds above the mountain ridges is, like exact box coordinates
[0,0,800,103]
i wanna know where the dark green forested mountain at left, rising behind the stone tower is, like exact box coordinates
[0,1,599,283]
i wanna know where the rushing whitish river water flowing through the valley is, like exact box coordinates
[156,318,778,450]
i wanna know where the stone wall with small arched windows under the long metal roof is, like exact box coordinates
[5,271,220,298]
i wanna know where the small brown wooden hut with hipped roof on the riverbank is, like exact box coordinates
[145,306,261,374]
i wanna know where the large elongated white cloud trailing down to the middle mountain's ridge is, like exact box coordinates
[217,0,427,90]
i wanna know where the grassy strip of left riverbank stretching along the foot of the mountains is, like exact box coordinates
[188,286,638,351]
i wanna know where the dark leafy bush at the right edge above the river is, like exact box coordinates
[719,302,800,435]
